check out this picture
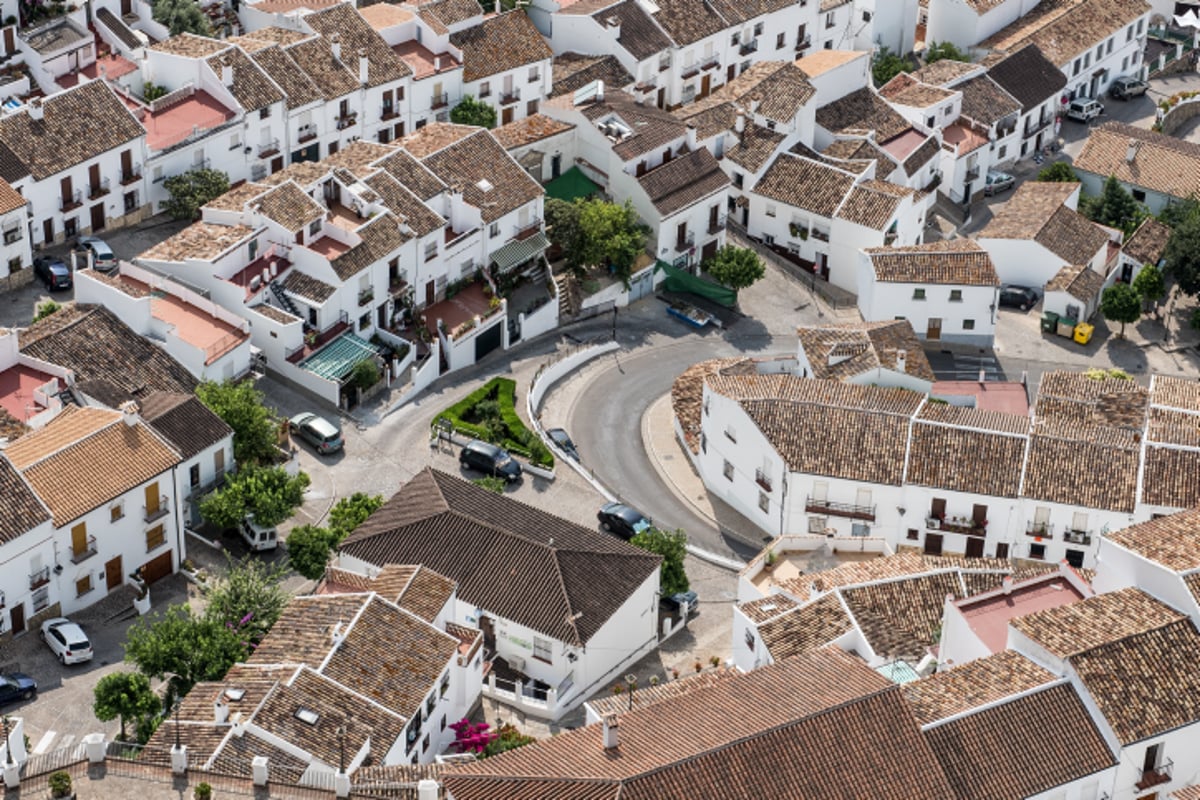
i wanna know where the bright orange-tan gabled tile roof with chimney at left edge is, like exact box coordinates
[5,407,180,528]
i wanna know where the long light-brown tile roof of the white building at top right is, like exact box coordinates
[978,0,1151,67]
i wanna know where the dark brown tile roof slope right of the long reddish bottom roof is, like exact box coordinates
[923,684,1116,800]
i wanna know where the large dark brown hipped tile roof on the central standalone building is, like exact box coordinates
[342,470,659,645]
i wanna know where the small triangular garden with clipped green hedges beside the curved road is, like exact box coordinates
[433,378,554,469]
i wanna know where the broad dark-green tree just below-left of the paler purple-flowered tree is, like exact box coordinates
[125,603,250,694]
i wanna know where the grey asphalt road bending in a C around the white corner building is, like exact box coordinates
[566,331,793,560]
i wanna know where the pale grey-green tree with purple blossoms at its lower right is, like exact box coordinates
[204,554,289,642]
